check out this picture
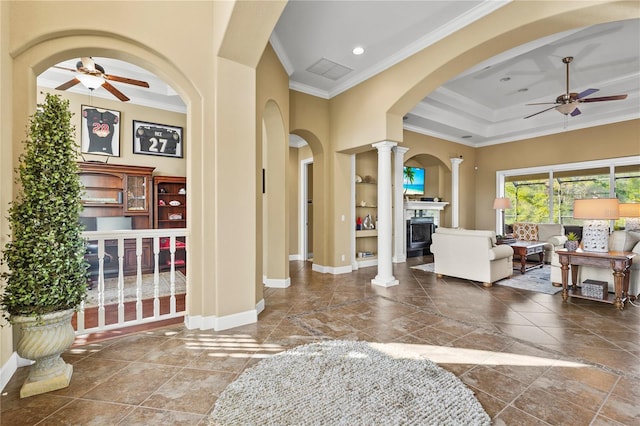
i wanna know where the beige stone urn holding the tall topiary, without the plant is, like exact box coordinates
[11,309,75,398]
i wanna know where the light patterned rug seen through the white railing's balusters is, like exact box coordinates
[85,271,186,307]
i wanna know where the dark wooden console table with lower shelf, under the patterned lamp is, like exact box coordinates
[556,249,636,310]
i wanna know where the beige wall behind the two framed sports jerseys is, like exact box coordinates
[37,87,189,176]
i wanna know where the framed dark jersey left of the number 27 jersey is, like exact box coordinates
[80,105,120,157]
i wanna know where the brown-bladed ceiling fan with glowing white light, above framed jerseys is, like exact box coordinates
[53,57,149,102]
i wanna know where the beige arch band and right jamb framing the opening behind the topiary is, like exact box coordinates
[8,33,206,326]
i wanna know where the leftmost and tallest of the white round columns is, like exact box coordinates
[371,141,398,287]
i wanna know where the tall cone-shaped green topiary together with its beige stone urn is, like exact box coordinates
[0,94,87,398]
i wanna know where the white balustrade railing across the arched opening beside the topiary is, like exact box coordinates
[76,228,188,335]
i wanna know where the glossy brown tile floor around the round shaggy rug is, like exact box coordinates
[0,257,640,426]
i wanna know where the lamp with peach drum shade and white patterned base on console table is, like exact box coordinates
[573,198,619,253]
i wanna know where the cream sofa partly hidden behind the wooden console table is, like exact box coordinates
[576,231,640,300]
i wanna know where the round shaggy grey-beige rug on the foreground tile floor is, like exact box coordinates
[209,341,490,426]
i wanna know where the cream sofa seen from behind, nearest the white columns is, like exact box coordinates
[431,227,513,287]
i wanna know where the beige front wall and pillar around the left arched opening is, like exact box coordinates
[0,1,288,376]
